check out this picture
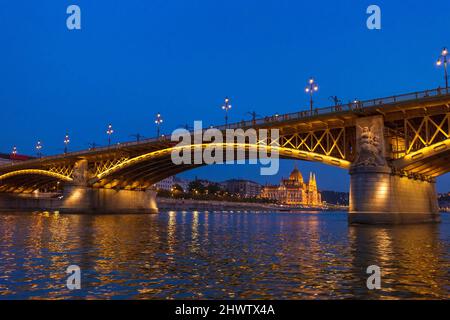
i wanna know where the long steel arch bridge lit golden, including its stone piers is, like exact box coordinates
[0,89,450,223]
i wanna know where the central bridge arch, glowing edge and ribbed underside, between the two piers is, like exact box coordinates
[90,143,351,189]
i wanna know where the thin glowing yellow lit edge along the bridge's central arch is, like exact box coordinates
[96,143,351,180]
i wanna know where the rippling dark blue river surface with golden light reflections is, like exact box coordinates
[0,212,450,299]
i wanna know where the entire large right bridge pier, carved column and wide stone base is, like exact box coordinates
[348,116,439,224]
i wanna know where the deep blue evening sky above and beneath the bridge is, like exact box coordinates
[0,0,450,191]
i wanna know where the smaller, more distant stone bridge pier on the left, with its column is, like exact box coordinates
[60,160,158,214]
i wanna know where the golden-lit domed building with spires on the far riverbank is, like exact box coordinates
[261,167,322,206]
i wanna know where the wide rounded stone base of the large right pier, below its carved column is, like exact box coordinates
[348,167,440,224]
